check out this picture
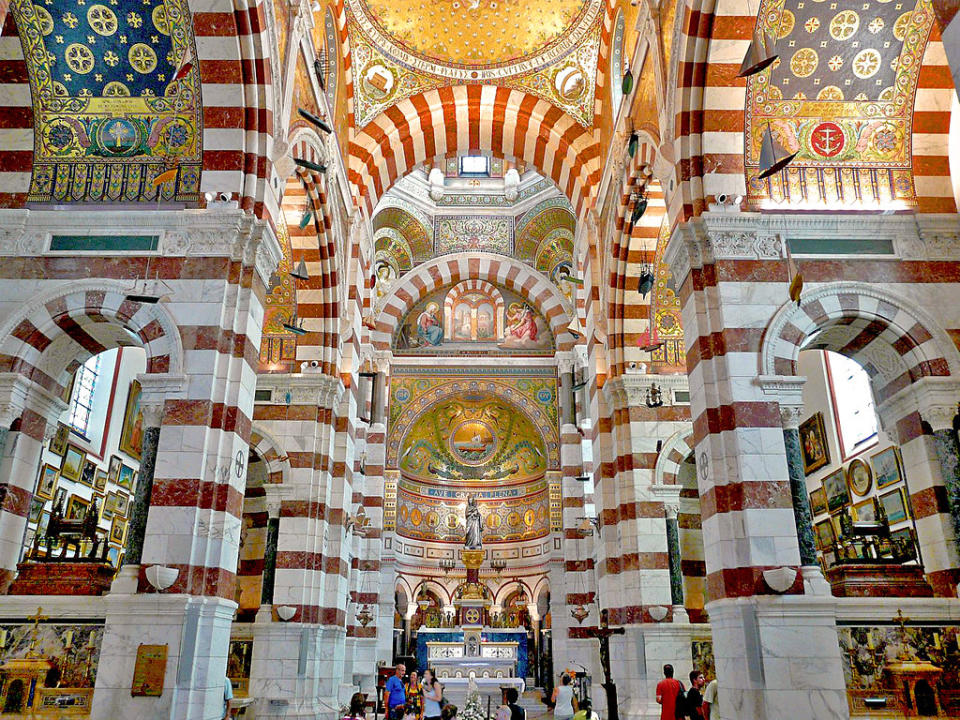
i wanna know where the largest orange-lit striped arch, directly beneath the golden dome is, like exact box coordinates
[349,85,601,216]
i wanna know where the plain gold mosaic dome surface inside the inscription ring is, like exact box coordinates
[363,0,588,67]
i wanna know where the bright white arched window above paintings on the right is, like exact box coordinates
[825,352,878,458]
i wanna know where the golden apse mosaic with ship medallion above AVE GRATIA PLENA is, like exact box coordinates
[386,366,560,470]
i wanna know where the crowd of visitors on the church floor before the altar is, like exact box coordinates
[343,663,720,720]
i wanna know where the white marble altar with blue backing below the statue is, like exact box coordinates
[417,627,528,681]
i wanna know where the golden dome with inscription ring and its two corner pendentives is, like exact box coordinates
[347,0,603,128]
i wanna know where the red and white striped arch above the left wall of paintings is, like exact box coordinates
[0,279,183,395]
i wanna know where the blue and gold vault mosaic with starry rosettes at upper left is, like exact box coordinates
[11,0,202,202]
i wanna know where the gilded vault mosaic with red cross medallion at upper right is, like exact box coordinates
[746,0,934,205]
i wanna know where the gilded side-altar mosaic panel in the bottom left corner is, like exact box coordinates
[0,611,103,717]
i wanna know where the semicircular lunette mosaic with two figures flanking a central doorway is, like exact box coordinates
[393,280,555,355]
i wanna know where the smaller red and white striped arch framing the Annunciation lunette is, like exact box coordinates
[370,252,573,350]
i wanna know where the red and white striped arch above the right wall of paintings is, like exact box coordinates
[760,282,960,403]
